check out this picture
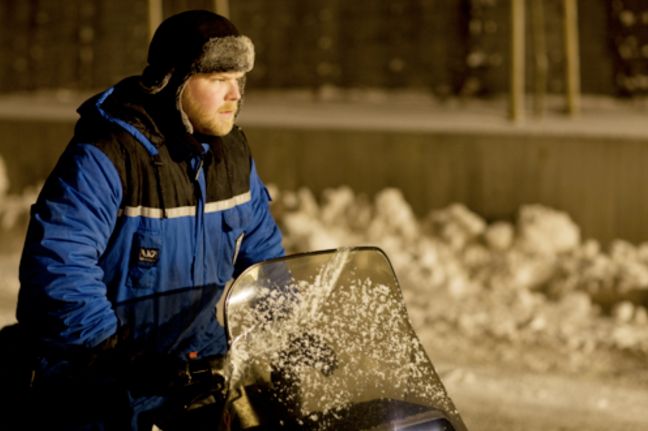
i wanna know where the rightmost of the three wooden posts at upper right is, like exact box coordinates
[563,0,580,116]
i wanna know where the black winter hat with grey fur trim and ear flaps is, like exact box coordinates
[140,10,254,132]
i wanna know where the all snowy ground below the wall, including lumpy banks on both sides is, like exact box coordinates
[0,161,648,430]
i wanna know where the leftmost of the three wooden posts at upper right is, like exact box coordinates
[509,0,525,122]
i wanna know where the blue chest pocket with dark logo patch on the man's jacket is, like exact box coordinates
[128,230,162,289]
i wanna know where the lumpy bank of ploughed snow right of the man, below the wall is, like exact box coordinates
[273,187,648,372]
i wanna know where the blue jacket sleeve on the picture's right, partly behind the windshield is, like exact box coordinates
[234,161,285,277]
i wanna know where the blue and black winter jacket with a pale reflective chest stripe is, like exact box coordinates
[17,78,284,358]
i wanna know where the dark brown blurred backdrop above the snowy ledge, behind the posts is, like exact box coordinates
[0,0,636,97]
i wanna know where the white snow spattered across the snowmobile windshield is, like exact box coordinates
[228,249,457,429]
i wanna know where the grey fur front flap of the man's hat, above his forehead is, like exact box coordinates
[192,36,254,73]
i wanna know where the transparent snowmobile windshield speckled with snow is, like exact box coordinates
[225,247,465,430]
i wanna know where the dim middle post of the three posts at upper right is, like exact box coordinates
[531,0,549,117]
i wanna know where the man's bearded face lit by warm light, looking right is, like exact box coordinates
[181,72,244,136]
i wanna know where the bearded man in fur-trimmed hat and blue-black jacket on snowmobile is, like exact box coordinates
[6,11,284,430]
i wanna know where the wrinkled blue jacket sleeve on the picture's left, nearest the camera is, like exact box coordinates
[17,144,122,348]
